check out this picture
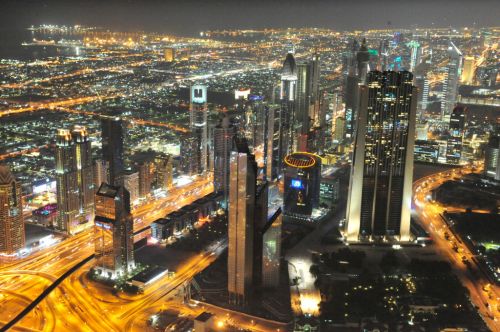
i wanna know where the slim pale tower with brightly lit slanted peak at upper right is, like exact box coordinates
[441,42,462,122]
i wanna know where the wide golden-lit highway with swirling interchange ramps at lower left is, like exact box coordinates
[0,176,215,331]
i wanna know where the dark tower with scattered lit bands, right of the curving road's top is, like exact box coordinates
[446,106,467,165]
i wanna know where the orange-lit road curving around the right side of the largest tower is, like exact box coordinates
[413,167,500,331]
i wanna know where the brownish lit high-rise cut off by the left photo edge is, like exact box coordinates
[0,165,25,255]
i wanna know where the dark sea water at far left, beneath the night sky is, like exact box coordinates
[0,29,83,61]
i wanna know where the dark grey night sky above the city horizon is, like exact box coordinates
[0,0,500,35]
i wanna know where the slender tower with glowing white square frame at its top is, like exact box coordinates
[189,85,208,173]
